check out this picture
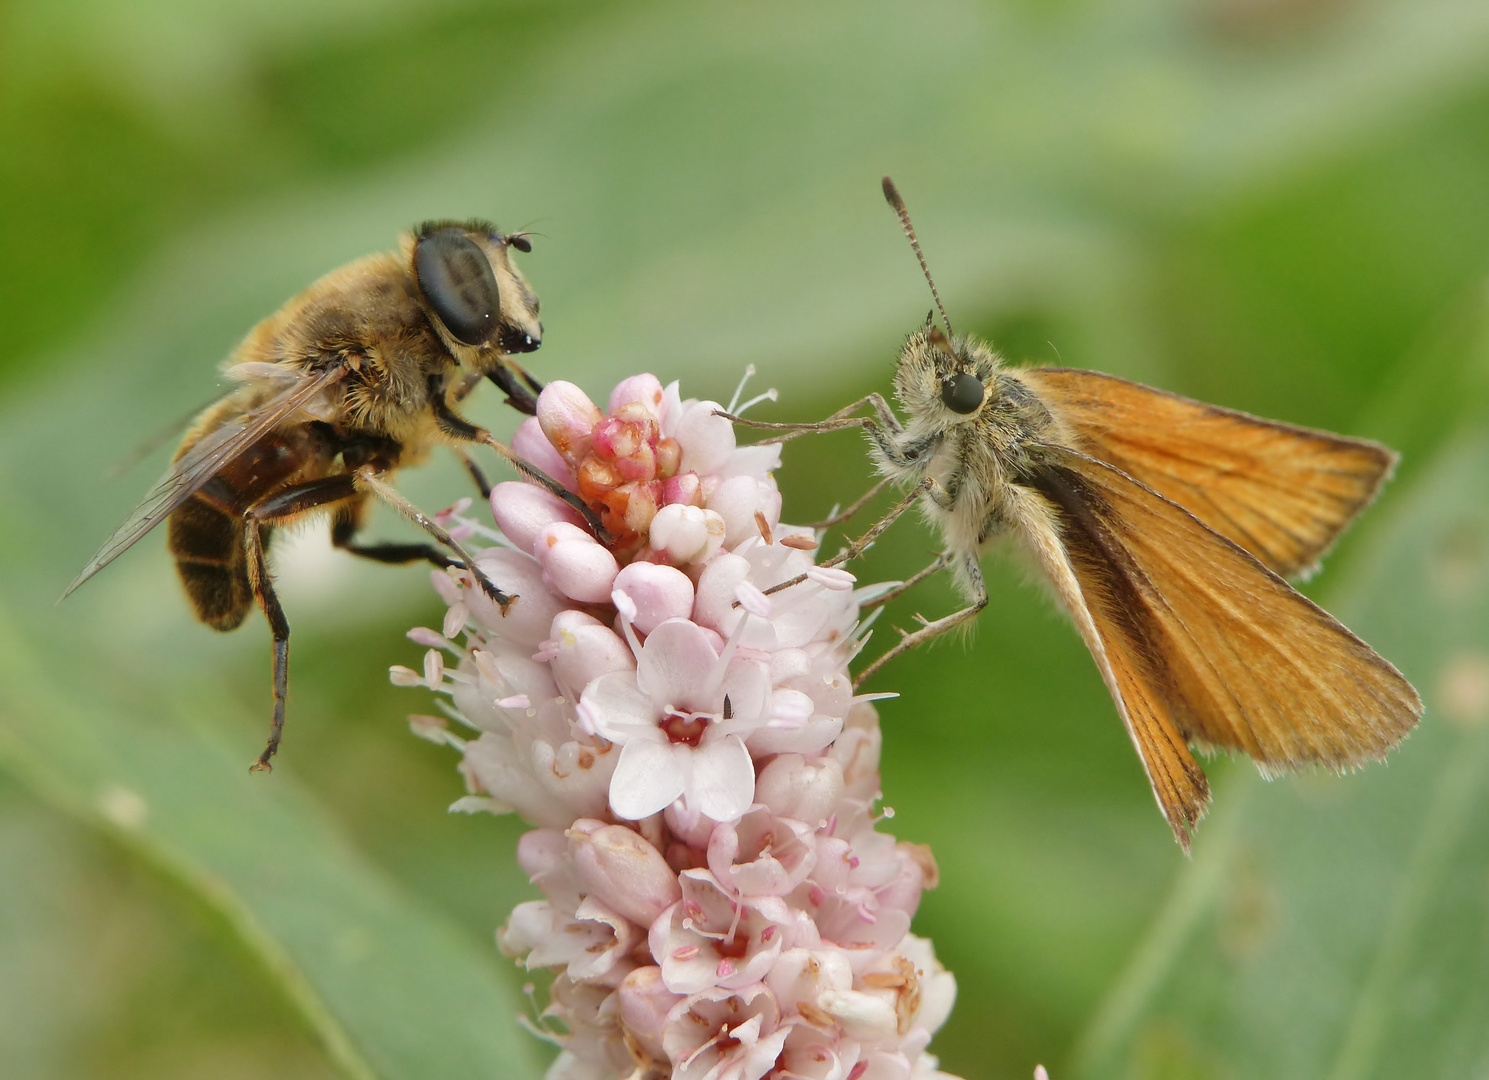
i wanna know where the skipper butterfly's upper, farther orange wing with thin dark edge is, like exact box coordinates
[1017,368,1395,576]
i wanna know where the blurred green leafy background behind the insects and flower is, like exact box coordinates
[0,0,1489,1080]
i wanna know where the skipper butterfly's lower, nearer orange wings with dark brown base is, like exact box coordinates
[1020,445,1422,846]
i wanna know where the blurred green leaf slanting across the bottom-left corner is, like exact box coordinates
[0,612,539,1080]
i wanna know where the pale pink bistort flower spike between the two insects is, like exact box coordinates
[393,375,956,1080]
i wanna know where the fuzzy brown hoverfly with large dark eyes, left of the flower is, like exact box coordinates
[63,220,599,770]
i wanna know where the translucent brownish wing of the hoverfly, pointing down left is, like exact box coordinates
[63,363,347,599]
